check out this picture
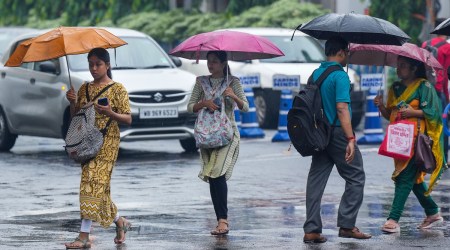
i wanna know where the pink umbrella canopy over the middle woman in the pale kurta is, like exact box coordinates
[169,30,284,61]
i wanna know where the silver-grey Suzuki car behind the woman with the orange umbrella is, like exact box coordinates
[0,28,197,152]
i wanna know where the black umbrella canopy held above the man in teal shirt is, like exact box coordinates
[297,13,410,45]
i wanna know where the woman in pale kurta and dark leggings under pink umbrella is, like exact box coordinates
[188,51,248,235]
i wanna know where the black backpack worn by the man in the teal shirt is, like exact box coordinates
[287,65,342,156]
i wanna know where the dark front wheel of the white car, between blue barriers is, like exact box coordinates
[253,89,281,129]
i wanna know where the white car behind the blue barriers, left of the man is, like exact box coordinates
[181,28,365,128]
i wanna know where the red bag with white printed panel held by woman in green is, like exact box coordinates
[378,117,417,160]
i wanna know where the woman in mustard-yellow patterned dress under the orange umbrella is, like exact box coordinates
[66,49,131,249]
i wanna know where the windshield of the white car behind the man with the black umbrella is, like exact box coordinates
[261,36,325,63]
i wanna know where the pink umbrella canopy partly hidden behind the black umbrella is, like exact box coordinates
[348,43,443,69]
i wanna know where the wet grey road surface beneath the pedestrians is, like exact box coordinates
[0,131,450,249]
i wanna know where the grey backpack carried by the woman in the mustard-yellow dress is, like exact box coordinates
[65,83,115,164]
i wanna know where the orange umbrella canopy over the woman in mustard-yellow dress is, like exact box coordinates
[5,27,127,67]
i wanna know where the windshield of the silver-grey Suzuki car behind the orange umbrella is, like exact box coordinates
[68,37,172,71]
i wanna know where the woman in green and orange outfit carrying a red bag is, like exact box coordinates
[374,56,445,233]
